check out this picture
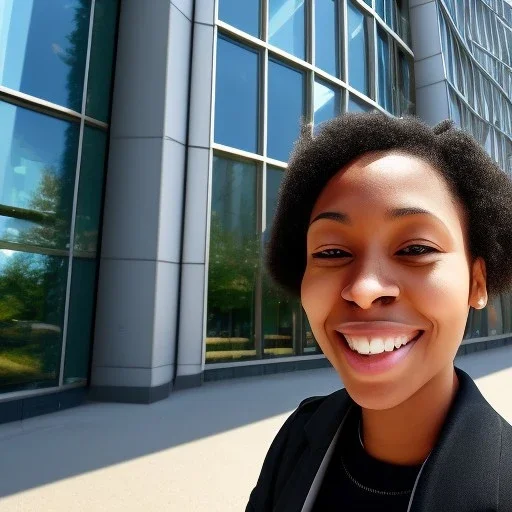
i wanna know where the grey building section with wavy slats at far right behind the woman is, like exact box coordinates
[411,0,512,344]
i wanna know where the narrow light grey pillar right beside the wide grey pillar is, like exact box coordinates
[175,0,215,389]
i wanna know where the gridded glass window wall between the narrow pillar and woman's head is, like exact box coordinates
[200,0,414,374]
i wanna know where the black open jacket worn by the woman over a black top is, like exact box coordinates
[246,369,512,512]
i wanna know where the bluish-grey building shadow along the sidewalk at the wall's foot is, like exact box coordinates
[0,346,512,496]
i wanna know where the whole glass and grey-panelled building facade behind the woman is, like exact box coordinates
[0,0,512,422]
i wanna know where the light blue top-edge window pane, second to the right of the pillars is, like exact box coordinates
[268,0,306,59]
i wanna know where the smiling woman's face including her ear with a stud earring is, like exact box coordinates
[301,152,487,409]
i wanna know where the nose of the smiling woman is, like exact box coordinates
[341,262,400,309]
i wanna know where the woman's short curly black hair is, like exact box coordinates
[266,112,512,296]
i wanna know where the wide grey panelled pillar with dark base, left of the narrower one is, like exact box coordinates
[91,0,194,402]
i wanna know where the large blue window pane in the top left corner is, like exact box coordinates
[0,0,91,111]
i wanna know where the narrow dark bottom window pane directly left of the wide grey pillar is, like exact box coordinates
[64,258,96,384]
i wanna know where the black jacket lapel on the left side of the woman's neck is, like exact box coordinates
[274,389,353,512]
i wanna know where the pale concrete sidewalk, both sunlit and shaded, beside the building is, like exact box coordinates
[0,346,512,512]
